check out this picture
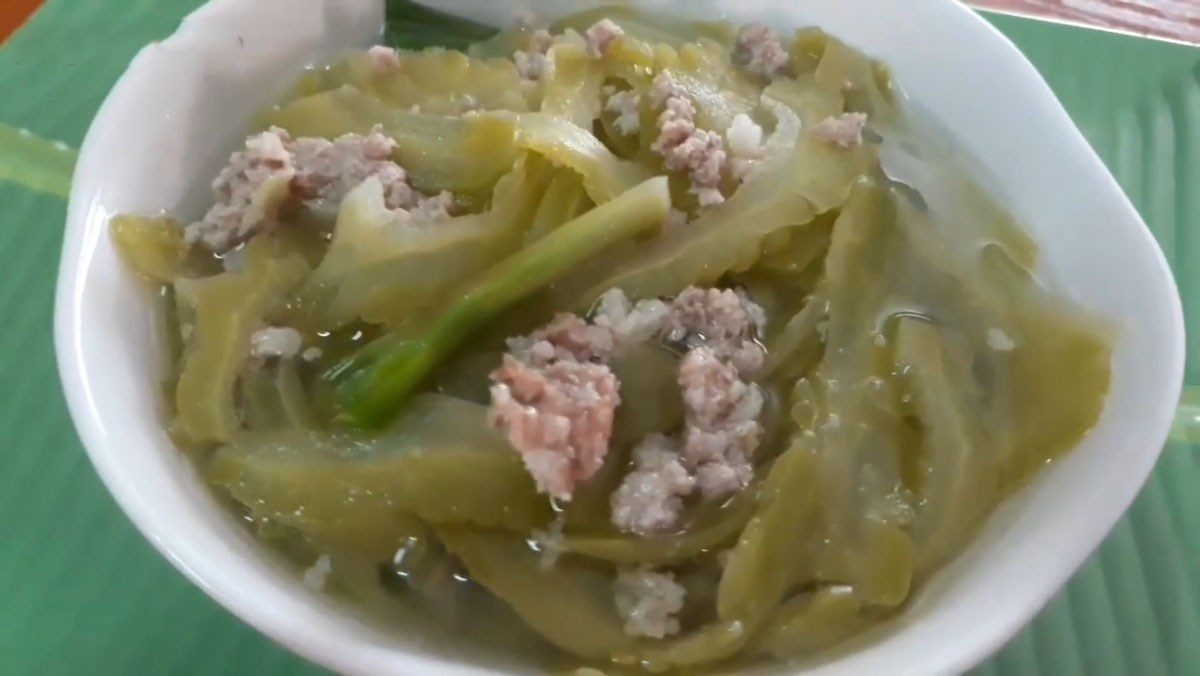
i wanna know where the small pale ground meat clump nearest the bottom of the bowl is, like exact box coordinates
[614,567,688,639]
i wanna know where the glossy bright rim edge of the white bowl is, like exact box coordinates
[54,0,1184,674]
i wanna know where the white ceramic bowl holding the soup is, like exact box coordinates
[55,0,1183,674]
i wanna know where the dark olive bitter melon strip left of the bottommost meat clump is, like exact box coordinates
[438,528,635,660]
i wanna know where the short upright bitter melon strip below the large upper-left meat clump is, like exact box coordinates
[174,238,308,443]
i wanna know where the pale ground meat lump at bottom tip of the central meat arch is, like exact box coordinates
[611,435,696,534]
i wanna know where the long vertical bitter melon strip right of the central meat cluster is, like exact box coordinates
[801,179,920,599]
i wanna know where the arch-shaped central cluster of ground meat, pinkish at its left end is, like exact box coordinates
[491,287,766,518]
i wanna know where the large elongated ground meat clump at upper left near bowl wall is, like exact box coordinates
[185,127,454,253]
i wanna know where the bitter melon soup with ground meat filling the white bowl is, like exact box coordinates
[112,10,1112,671]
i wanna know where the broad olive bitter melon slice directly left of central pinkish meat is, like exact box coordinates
[209,395,551,556]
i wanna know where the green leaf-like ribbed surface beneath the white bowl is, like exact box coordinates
[0,0,1200,676]
